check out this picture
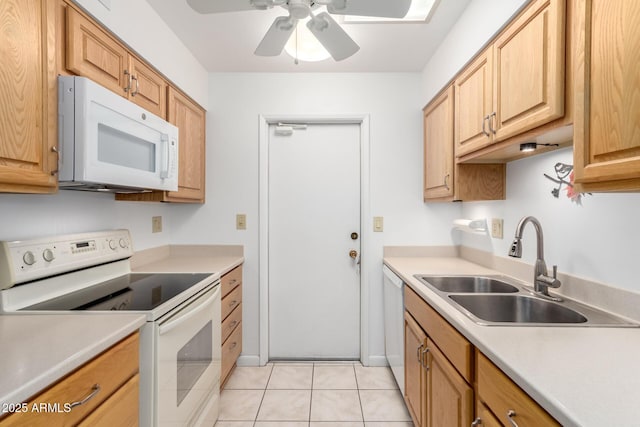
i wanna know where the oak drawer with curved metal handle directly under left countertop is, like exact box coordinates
[0,332,139,427]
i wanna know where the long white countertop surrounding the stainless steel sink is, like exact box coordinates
[384,257,640,427]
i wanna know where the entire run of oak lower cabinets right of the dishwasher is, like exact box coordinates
[404,286,560,427]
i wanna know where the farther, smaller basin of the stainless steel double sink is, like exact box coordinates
[416,275,518,294]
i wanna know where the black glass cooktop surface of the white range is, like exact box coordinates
[23,273,211,311]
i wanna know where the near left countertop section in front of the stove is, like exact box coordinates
[0,313,145,410]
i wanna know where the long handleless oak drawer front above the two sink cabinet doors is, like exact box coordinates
[404,286,473,384]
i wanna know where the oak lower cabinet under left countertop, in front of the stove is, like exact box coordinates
[0,332,140,427]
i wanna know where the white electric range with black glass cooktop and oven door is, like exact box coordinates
[0,230,220,427]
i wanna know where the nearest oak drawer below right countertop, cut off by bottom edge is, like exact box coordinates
[477,352,560,427]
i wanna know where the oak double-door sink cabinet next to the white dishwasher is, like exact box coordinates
[405,287,473,427]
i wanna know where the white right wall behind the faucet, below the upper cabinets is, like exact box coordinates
[463,148,640,292]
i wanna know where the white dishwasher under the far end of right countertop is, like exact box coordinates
[382,265,404,395]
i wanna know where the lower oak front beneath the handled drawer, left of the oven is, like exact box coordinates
[78,375,140,427]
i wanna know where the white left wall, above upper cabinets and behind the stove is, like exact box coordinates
[0,0,209,250]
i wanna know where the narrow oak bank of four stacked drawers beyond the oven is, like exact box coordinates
[220,266,242,388]
